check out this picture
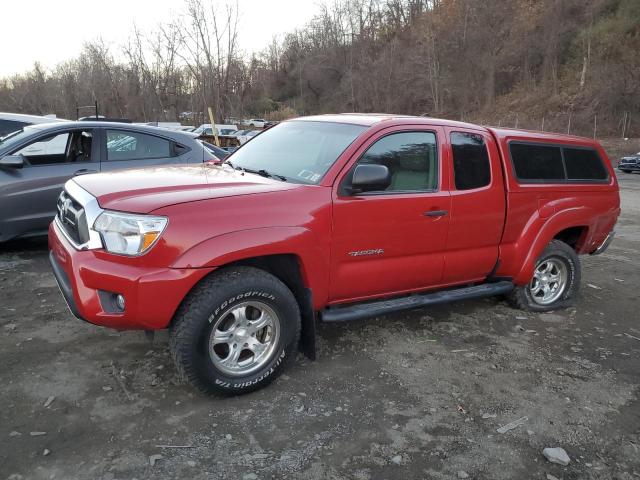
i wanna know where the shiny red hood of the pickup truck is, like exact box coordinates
[73,164,297,213]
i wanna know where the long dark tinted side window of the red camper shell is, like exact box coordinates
[509,142,609,183]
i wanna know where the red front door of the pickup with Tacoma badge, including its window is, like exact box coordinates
[330,127,451,303]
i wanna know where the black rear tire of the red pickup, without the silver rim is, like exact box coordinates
[509,240,581,312]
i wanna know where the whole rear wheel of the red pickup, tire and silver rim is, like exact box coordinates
[511,240,580,312]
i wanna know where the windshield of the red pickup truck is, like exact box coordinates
[229,121,366,185]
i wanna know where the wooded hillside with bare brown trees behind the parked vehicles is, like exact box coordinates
[0,0,640,136]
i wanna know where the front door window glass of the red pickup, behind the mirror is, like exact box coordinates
[358,132,438,192]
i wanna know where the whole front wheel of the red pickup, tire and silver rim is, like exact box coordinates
[170,267,300,395]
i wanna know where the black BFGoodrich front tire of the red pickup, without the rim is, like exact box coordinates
[169,267,301,396]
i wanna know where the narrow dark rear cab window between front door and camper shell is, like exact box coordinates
[451,132,491,190]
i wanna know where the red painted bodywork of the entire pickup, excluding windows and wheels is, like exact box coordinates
[49,115,620,329]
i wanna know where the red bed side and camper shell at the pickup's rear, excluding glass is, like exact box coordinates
[489,128,620,285]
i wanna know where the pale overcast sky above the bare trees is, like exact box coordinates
[0,0,320,77]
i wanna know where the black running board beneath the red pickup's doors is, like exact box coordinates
[322,281,513,322]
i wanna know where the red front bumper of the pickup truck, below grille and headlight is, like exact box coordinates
[49,223,214,330]
